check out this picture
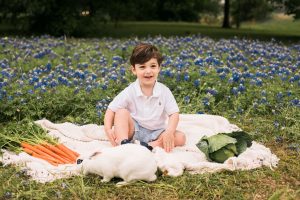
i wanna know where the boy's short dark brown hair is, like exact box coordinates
[130,43,163,67]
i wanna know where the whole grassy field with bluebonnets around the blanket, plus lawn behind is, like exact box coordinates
[0,16,300,200]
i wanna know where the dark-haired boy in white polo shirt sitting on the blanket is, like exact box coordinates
[104,44,186,152]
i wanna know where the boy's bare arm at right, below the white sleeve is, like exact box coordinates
[163,112,179,152]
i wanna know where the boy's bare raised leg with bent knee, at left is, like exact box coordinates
[114,109,134,145]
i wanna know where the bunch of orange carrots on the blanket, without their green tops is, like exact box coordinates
[21,142,79,166]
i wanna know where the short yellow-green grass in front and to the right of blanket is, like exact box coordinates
[0,110,300,200]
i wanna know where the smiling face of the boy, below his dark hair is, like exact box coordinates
[131,58,160,86]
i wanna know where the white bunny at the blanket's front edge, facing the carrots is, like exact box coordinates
[82,144,157,186]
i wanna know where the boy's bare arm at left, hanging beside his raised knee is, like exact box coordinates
[104,109,117,146]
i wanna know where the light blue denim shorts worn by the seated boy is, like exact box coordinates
[132,120,165,143]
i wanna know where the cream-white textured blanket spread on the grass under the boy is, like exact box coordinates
[0,114,279,182]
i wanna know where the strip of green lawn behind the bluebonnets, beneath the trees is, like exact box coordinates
[0,19,300,42]
